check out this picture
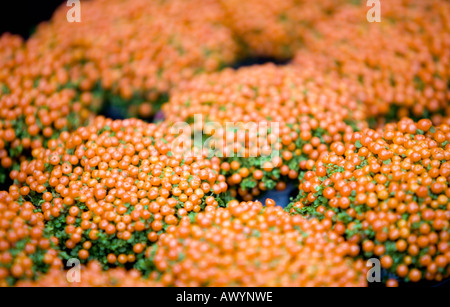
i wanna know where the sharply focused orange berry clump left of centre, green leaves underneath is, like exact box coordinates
[10,117,227,272]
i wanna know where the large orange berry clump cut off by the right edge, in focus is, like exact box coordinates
[288,118,450,282]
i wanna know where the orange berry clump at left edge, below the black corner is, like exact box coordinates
[0,34,99,179]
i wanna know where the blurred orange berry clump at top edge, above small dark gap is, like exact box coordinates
[219,0,349,60]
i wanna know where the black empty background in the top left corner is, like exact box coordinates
[0,0,67,38]
